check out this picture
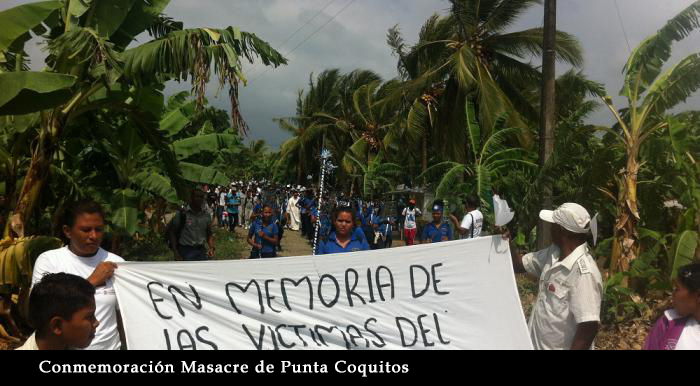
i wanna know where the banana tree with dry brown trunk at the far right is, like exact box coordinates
[603,1,700,278]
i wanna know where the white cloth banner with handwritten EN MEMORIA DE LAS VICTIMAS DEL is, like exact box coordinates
[115,236,532,350]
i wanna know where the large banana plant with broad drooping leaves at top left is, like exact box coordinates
[0,0,286,237]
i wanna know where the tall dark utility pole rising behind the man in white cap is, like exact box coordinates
[537,0,557,249]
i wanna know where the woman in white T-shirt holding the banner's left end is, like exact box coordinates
[32,201,124,350]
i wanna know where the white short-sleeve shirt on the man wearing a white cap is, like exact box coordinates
[523,244,603,350]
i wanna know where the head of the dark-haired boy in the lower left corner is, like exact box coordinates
[29,273,99,348]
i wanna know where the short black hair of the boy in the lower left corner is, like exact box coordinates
[29,272,95,332]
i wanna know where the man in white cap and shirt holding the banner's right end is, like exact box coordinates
[504,203,603,350]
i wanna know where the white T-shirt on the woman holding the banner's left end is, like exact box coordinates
[32,247,124,350]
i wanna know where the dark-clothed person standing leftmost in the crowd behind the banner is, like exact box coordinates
[167,189,216,261]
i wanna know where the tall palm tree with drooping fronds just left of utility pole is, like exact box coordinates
[392,0,583,160]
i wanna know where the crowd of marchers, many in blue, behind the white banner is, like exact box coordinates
[191,181,484,260]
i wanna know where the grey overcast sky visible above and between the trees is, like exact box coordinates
[6,0,700,149]
